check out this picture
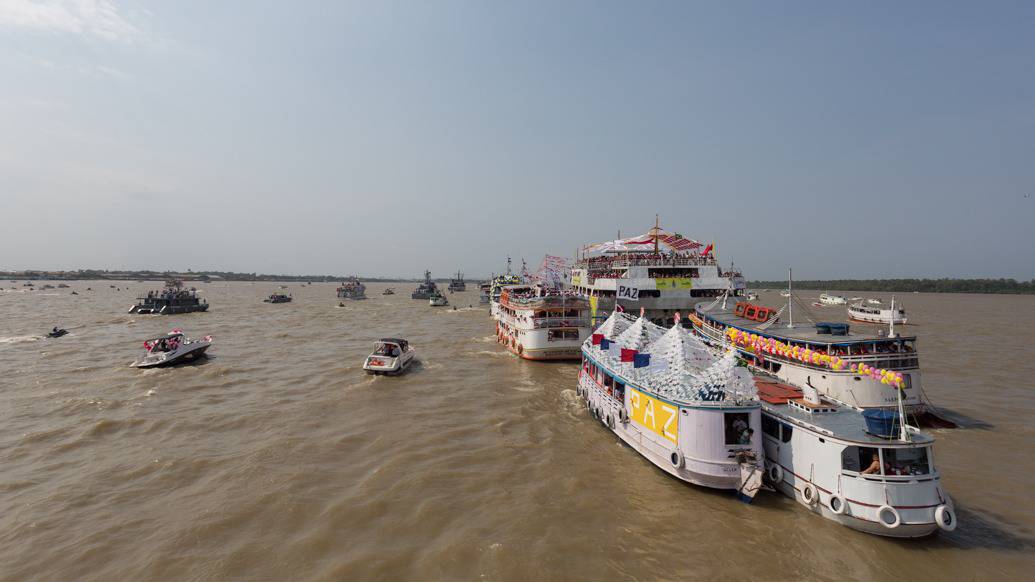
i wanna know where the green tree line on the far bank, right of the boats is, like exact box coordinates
[748,279,1035,295]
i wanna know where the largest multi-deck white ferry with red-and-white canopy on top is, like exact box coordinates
[571,218,746,326]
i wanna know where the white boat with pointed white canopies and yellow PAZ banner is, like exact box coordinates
[578,313,764,500]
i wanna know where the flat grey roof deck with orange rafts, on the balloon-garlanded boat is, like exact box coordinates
[693,300,916,346]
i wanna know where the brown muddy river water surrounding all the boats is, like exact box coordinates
[0,281,1035,580]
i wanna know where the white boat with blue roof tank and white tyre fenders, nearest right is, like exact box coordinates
[756,377,956,537]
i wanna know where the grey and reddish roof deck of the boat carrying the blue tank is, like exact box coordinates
[755,377,935,447]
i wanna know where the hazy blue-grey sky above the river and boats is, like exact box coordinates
[0,0,1035,279]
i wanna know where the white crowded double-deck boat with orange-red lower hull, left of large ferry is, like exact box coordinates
[496,284,592,360]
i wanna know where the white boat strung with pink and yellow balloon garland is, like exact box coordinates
[690,299,924,413]
